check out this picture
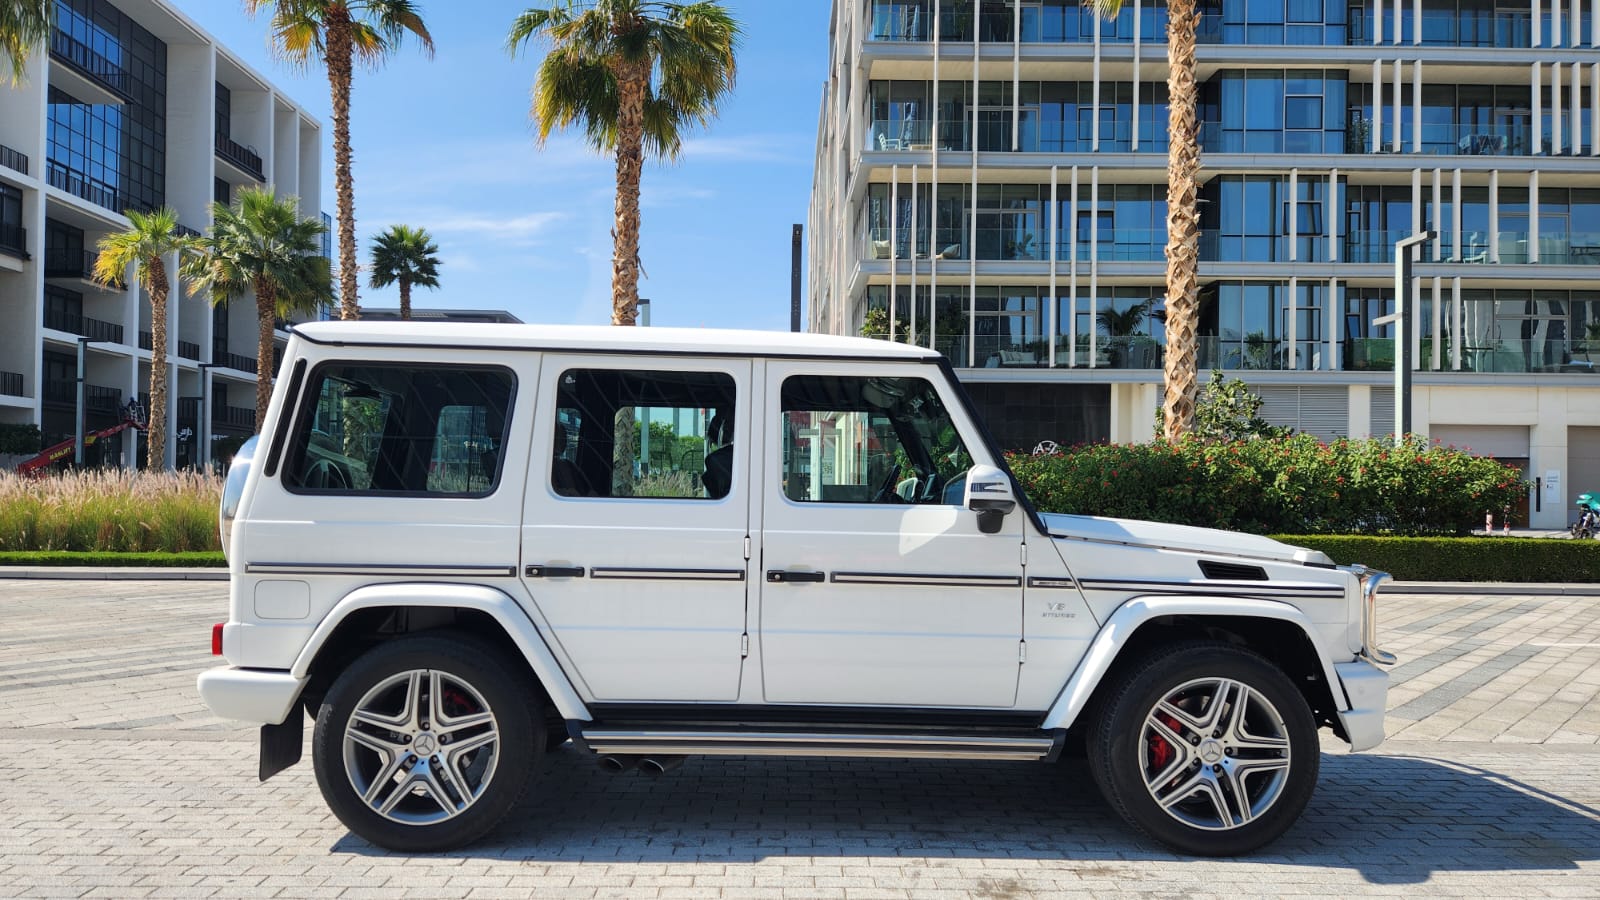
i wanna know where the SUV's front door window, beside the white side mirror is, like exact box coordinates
[782,375,973,506]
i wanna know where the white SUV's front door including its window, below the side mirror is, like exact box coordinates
[758,360,1024,708]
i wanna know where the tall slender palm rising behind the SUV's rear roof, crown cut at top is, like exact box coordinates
[245,0,434,319]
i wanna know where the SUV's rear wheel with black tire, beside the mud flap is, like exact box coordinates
[312,633,546,852]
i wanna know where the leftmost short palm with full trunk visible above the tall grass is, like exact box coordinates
[94,207,197,469]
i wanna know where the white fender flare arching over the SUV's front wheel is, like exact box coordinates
[1042,594,1350,729]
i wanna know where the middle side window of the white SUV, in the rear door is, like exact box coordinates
[549,368,736,500]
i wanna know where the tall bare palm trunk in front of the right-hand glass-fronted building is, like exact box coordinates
[1091,0,1200,440]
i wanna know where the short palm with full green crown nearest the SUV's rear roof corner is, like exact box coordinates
[182,187,333,432]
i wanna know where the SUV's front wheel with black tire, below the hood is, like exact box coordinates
[1088,644,1322,857]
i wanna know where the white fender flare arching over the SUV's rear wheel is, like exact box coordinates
[290,583,590,721]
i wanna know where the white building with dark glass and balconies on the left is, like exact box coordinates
[0,0,323,464]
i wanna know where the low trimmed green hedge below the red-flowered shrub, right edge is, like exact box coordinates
[1275,535,1600,581]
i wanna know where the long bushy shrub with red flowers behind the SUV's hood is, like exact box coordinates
[1008,434,1528,535]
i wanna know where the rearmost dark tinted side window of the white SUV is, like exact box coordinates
[283,364,517,496]
